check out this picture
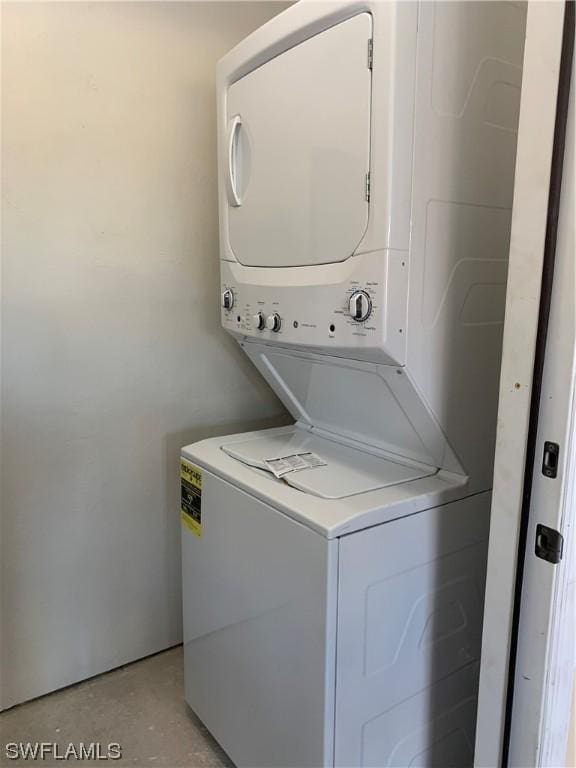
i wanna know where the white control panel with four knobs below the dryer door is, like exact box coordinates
[221,251,408,365]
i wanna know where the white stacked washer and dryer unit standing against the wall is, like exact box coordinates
[182,1,525,768]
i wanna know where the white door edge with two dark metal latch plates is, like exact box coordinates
[507,43,576,768]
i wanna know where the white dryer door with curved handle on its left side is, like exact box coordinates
[223,13,372,267]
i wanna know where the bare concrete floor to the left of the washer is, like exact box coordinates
[0,648,232,768]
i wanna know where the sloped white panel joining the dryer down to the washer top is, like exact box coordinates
[242,341,466,474]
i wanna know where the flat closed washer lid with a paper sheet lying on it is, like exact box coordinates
[222,427,437,499]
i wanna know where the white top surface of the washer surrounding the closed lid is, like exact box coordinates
[182,426,466,538]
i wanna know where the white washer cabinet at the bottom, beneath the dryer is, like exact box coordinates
[182,427,490,768]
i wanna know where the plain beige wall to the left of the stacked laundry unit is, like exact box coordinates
[1,2,283,706]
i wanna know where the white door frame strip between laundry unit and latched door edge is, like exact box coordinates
[475,2,574,768]
